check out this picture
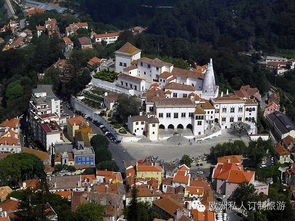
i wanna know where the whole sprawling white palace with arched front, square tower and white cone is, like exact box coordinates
[115,43,258,140]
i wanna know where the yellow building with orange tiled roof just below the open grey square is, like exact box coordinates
[136,165,163,184]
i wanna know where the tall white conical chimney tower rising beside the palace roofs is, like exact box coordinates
[201,58,219,99]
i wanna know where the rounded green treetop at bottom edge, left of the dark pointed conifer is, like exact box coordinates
[75,203,104,221]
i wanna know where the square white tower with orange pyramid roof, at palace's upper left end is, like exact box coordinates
[115,42,141,73]
